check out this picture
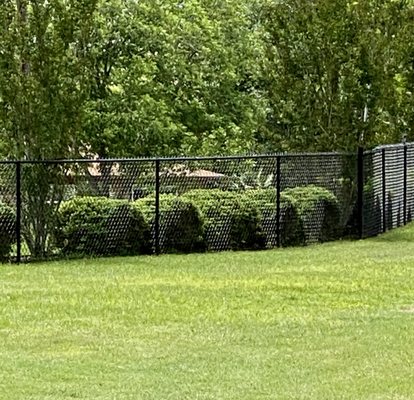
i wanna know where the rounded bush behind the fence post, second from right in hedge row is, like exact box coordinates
[243,189,305,247]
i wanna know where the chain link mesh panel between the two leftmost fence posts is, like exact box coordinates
[16,161,155,259]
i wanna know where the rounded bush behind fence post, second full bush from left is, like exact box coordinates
[133,194,205,253]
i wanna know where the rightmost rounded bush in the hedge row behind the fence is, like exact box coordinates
[282,185,342,243]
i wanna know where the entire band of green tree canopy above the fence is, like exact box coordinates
[0,0,414,159]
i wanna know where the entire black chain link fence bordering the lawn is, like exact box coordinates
[0,144,414,262]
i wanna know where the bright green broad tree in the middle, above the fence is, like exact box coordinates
[80,0,265,156]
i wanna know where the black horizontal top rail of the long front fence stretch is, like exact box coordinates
[0,152,355,165]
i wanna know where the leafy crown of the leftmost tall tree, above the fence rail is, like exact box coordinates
[0,0,95,159]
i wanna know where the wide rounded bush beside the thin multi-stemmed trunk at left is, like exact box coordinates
[55,197,151,255]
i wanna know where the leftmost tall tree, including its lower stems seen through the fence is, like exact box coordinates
[0,0,96,257]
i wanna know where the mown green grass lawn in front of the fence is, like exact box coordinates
[0,226,414,400]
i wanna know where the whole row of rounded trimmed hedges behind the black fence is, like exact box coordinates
[51,186,340,255]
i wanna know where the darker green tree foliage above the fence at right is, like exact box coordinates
[258,0,413,151]
